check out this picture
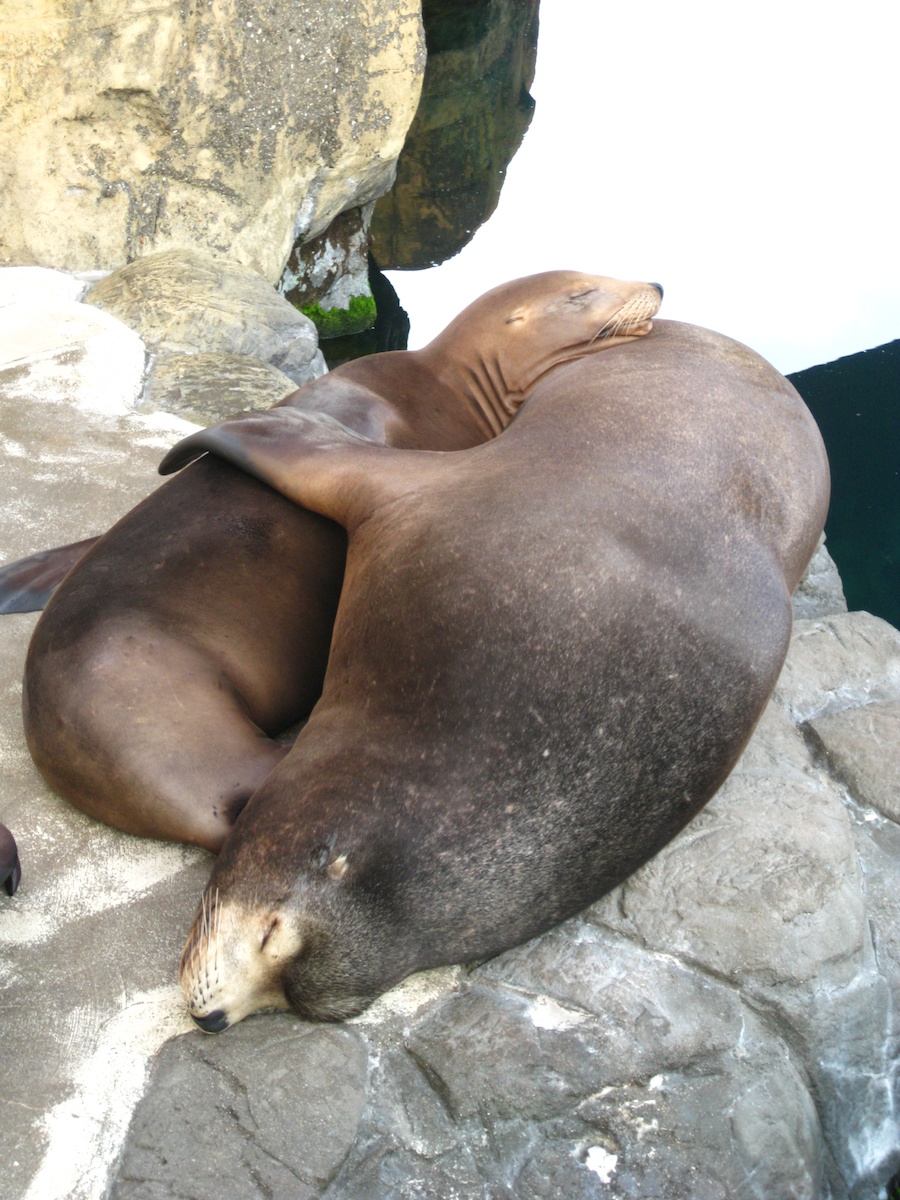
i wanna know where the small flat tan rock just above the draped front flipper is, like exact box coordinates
[138,354,303,425]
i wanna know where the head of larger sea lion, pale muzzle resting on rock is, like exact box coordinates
[180,788,414,1033]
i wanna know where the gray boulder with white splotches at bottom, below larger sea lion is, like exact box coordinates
[400,955,821,1198]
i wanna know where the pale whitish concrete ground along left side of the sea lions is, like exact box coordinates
[0,269,208,1200]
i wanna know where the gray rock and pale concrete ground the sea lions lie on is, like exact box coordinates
[0,272,900,1200]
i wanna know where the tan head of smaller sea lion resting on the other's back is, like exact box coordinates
[421,271,662,434]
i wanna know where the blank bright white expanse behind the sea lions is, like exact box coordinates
[390,0,900,372]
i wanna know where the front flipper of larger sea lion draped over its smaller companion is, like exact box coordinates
[160,408,448,529]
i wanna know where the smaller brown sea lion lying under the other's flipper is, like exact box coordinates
[12,271,660,851]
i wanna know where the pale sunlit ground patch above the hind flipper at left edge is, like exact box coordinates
[0,270,158,559]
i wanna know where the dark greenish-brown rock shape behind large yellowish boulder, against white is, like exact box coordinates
[370,0,538,270]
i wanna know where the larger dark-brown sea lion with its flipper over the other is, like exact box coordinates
[169,322,829,1032]
